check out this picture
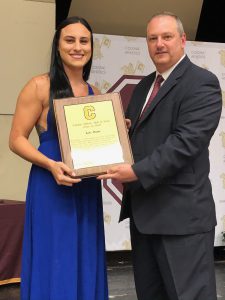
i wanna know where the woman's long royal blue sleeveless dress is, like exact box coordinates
[21,86,108,300]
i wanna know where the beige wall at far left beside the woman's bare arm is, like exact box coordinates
[0,0,55,200]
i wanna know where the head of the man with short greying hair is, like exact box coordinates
[147,16,186,73]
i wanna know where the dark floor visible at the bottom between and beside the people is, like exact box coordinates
[0,247,225,300]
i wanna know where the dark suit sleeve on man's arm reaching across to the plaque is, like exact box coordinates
[132,73,222,190]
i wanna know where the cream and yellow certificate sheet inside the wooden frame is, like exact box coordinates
[64,100,124,169]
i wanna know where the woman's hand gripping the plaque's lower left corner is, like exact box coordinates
[48,160,81,186]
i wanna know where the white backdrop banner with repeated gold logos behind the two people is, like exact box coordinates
[89,34,225,251]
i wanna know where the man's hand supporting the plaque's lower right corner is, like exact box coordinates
[97,164,138,182]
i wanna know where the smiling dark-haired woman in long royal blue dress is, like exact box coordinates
[9,17,108,300]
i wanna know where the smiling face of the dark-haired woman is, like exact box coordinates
[58,23,92,69]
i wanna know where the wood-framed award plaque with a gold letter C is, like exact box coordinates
[53,93,133,177]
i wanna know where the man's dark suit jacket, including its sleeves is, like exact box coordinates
[120,56,222,235]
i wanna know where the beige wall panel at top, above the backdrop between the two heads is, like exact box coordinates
[69,0,203,40]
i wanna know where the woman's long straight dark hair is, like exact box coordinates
[49,16,93,102]
